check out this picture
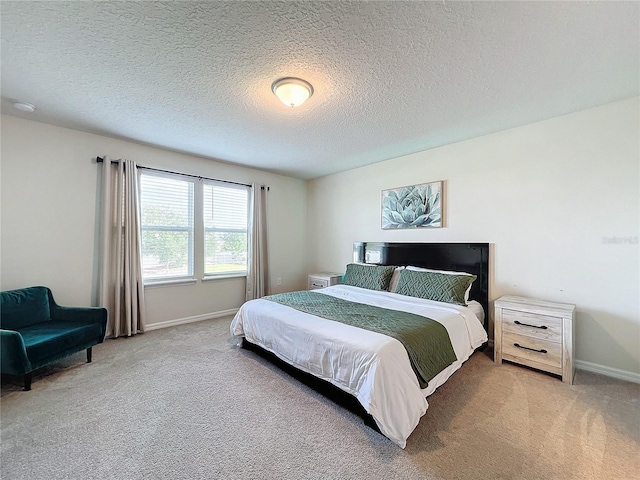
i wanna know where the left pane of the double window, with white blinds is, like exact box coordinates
[140,173,194,280]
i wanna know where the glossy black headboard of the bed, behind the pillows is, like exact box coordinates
[353,242,489,326]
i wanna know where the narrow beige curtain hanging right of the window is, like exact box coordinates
[246,183,269,300]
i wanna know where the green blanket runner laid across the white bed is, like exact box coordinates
[263,291,457,388]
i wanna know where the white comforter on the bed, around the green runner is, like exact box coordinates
[231,285,487,448]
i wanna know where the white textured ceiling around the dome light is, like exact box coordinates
[0,1,640,179]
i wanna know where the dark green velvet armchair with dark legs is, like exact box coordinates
[0,287,107,390]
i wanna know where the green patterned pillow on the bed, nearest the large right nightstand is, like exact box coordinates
[396,270,477,306]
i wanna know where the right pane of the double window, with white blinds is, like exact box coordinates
[203,182,249,275]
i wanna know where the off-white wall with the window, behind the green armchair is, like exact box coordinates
[0,115,307,325]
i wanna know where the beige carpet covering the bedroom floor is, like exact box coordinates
[0,319,640,480]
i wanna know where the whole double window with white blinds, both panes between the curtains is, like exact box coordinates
[140,171,250,283]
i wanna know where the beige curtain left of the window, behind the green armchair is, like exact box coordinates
[99,157,145,337]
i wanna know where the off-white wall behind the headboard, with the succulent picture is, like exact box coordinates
[307,98,640,374]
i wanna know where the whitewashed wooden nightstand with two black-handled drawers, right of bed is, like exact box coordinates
[493,296,576,384]
